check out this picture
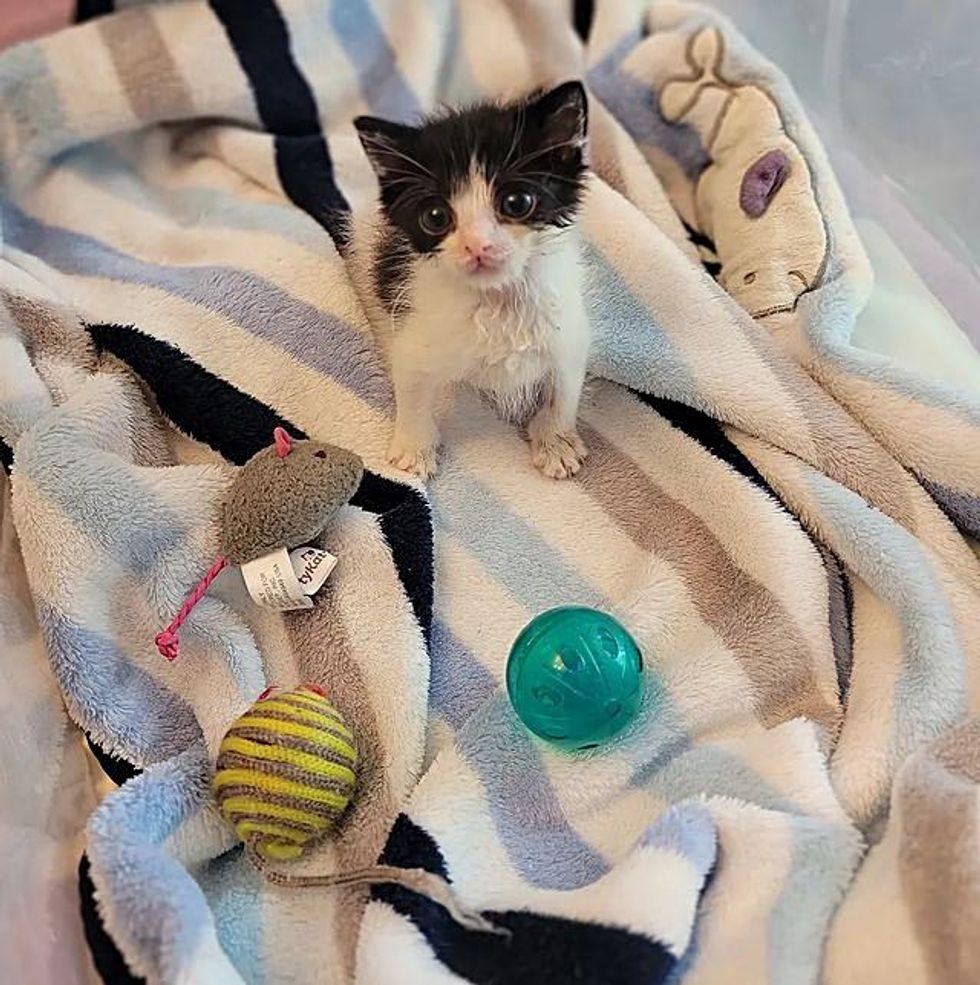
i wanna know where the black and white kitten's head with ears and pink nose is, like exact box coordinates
[354,82,586,290]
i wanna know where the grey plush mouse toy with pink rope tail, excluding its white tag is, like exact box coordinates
[156,427,364,660]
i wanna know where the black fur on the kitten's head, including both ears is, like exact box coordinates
[354,82,587,254]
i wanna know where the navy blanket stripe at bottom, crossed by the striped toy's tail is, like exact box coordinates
[372,815,676,985]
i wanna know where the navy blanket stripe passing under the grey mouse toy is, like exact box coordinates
[86,324,434,642]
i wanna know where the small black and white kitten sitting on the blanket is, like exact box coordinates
[354,82,589,479]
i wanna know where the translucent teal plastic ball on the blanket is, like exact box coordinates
[507,606,643,750]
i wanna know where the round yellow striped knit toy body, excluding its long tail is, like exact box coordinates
[212,684,357,861]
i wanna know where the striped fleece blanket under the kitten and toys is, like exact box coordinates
[0,0,980,985]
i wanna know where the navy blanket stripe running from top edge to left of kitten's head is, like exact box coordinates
[210,0,350,250]
